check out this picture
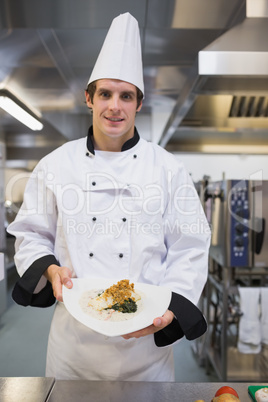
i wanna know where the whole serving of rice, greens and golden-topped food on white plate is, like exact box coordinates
[80,279,142,321]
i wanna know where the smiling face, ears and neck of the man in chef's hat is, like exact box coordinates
[86,79,142,149]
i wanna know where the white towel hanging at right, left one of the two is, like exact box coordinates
[237,287,261,353]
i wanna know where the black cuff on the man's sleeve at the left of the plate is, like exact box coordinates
[12,255,59,307]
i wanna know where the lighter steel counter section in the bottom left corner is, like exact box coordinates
[0,377,55,402]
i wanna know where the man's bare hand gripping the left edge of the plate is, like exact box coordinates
[44,264,73,302]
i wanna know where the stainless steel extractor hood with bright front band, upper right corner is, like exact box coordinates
[198,0,268,77]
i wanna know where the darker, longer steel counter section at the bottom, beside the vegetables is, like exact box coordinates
[48,380,268,402]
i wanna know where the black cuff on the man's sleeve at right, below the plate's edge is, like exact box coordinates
[154,292,207,346]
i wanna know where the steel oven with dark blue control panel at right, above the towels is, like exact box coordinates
[203,180,268,267]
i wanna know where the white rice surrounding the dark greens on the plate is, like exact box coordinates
[79,289,144,322]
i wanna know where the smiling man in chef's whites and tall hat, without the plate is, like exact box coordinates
[8,13,210,381]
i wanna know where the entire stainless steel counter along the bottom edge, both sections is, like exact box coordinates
[0,377,268,402]
